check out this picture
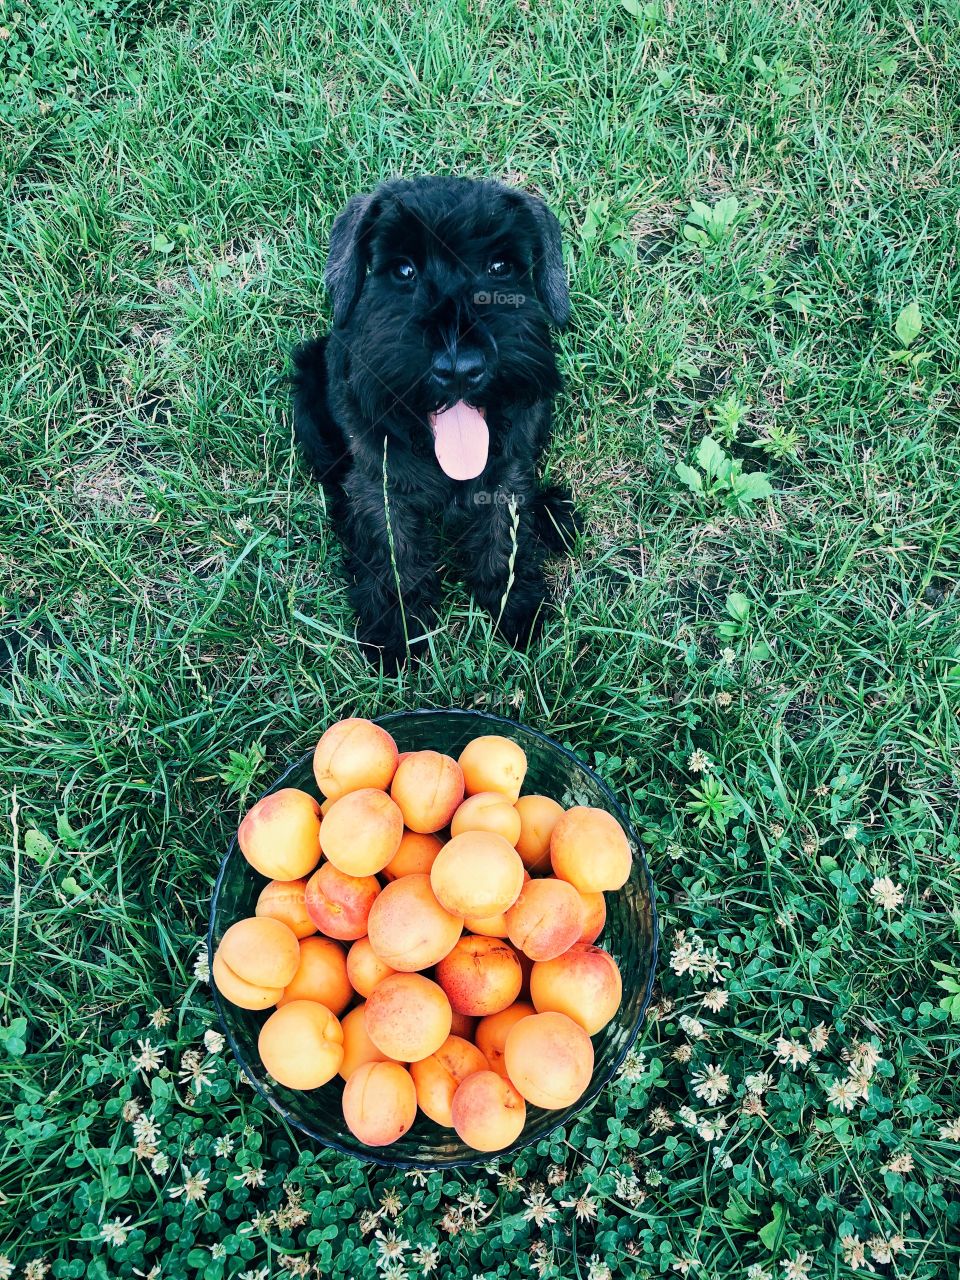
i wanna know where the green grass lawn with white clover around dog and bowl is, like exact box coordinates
[0,0,960,1280]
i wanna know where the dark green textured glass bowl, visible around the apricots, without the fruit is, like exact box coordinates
[207,709,658,1169]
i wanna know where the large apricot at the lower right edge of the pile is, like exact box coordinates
[503,1014,594,1111]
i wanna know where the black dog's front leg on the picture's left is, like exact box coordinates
[343,471,439,672]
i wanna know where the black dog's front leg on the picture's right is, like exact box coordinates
[460,484,547,649]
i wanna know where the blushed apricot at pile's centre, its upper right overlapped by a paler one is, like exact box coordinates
[367,874,463,973]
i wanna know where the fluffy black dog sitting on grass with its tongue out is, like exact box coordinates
[294,178,576,669]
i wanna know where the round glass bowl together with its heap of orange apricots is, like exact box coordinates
[209,709,658,1169]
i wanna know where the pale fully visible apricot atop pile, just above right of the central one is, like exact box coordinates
[430,831,524,918]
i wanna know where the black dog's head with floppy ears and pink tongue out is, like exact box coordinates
[326,178,570,480]
